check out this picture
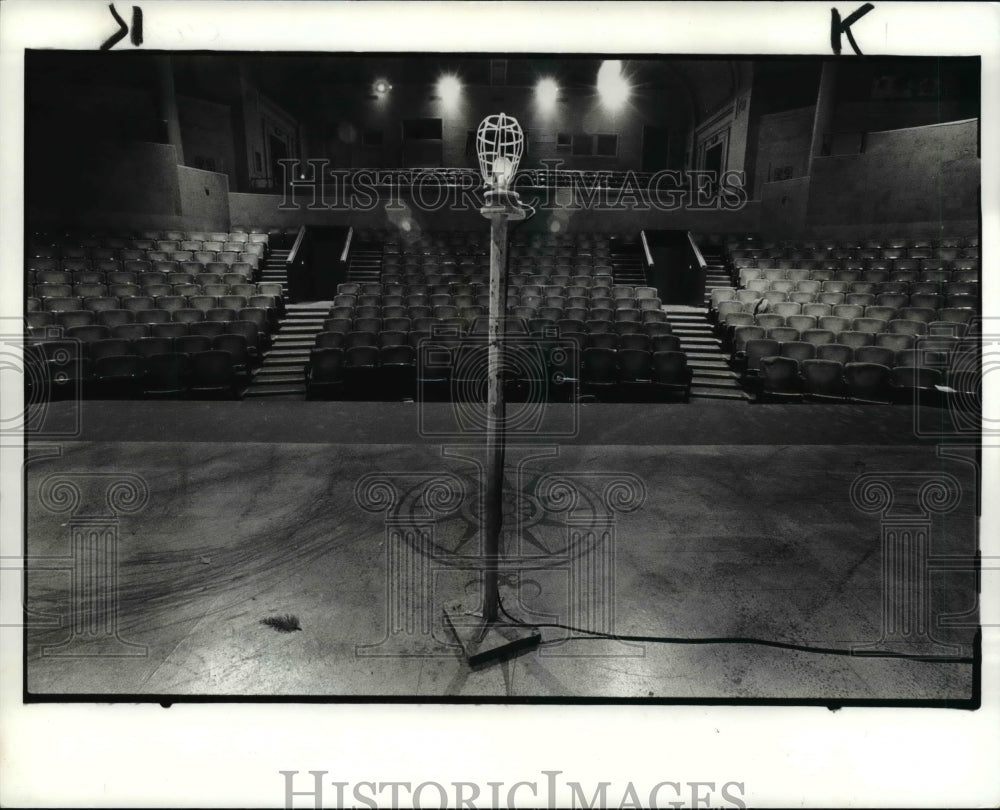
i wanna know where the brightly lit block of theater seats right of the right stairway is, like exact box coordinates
[710,236,981,403]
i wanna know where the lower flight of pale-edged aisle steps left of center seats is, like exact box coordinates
[244,301,332,399]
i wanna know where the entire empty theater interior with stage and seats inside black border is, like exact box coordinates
[19,51,982,706]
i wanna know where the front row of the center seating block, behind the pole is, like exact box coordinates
[306,342,692,403]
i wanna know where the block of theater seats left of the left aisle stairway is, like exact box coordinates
[25,230,274,398]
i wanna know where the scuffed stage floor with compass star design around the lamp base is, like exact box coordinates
[25,400,978,703]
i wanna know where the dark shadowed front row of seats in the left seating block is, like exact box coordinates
[24,334,252,402]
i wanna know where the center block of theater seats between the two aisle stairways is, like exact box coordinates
[306,232,691,401]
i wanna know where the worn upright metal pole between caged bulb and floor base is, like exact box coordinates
[483,210,507,623]
